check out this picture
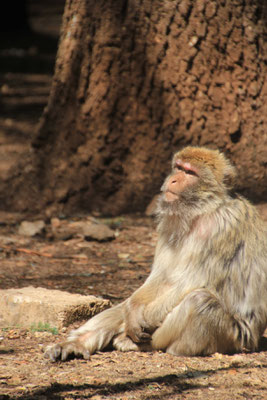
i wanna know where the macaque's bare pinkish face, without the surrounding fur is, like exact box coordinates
[161,159,199,203]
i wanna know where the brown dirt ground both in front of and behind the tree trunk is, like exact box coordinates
[0,4,267,400]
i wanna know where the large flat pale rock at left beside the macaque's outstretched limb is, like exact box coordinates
[0,286,111,329]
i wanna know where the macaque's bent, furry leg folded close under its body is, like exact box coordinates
[152,289,250,356]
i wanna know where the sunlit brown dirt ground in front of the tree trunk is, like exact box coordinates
[0,214,267,400]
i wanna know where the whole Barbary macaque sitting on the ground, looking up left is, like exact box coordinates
[45,147,267,361]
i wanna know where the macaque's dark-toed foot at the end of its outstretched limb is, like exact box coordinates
[44,341,90,362]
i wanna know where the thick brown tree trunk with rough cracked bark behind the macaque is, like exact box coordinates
[3,0,267,214]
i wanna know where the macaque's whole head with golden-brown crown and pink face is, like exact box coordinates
[161,147,236,207]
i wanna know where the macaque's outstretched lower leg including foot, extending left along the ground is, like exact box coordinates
[44,303,125,362]
